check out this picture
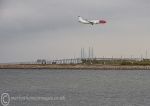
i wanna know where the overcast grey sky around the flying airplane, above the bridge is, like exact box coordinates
[0,0,150,63]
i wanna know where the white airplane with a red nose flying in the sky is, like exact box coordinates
[78,16,106,25]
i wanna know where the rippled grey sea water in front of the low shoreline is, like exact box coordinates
[0,69,150,106]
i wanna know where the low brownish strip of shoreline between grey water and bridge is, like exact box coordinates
[0,64,150,70]
